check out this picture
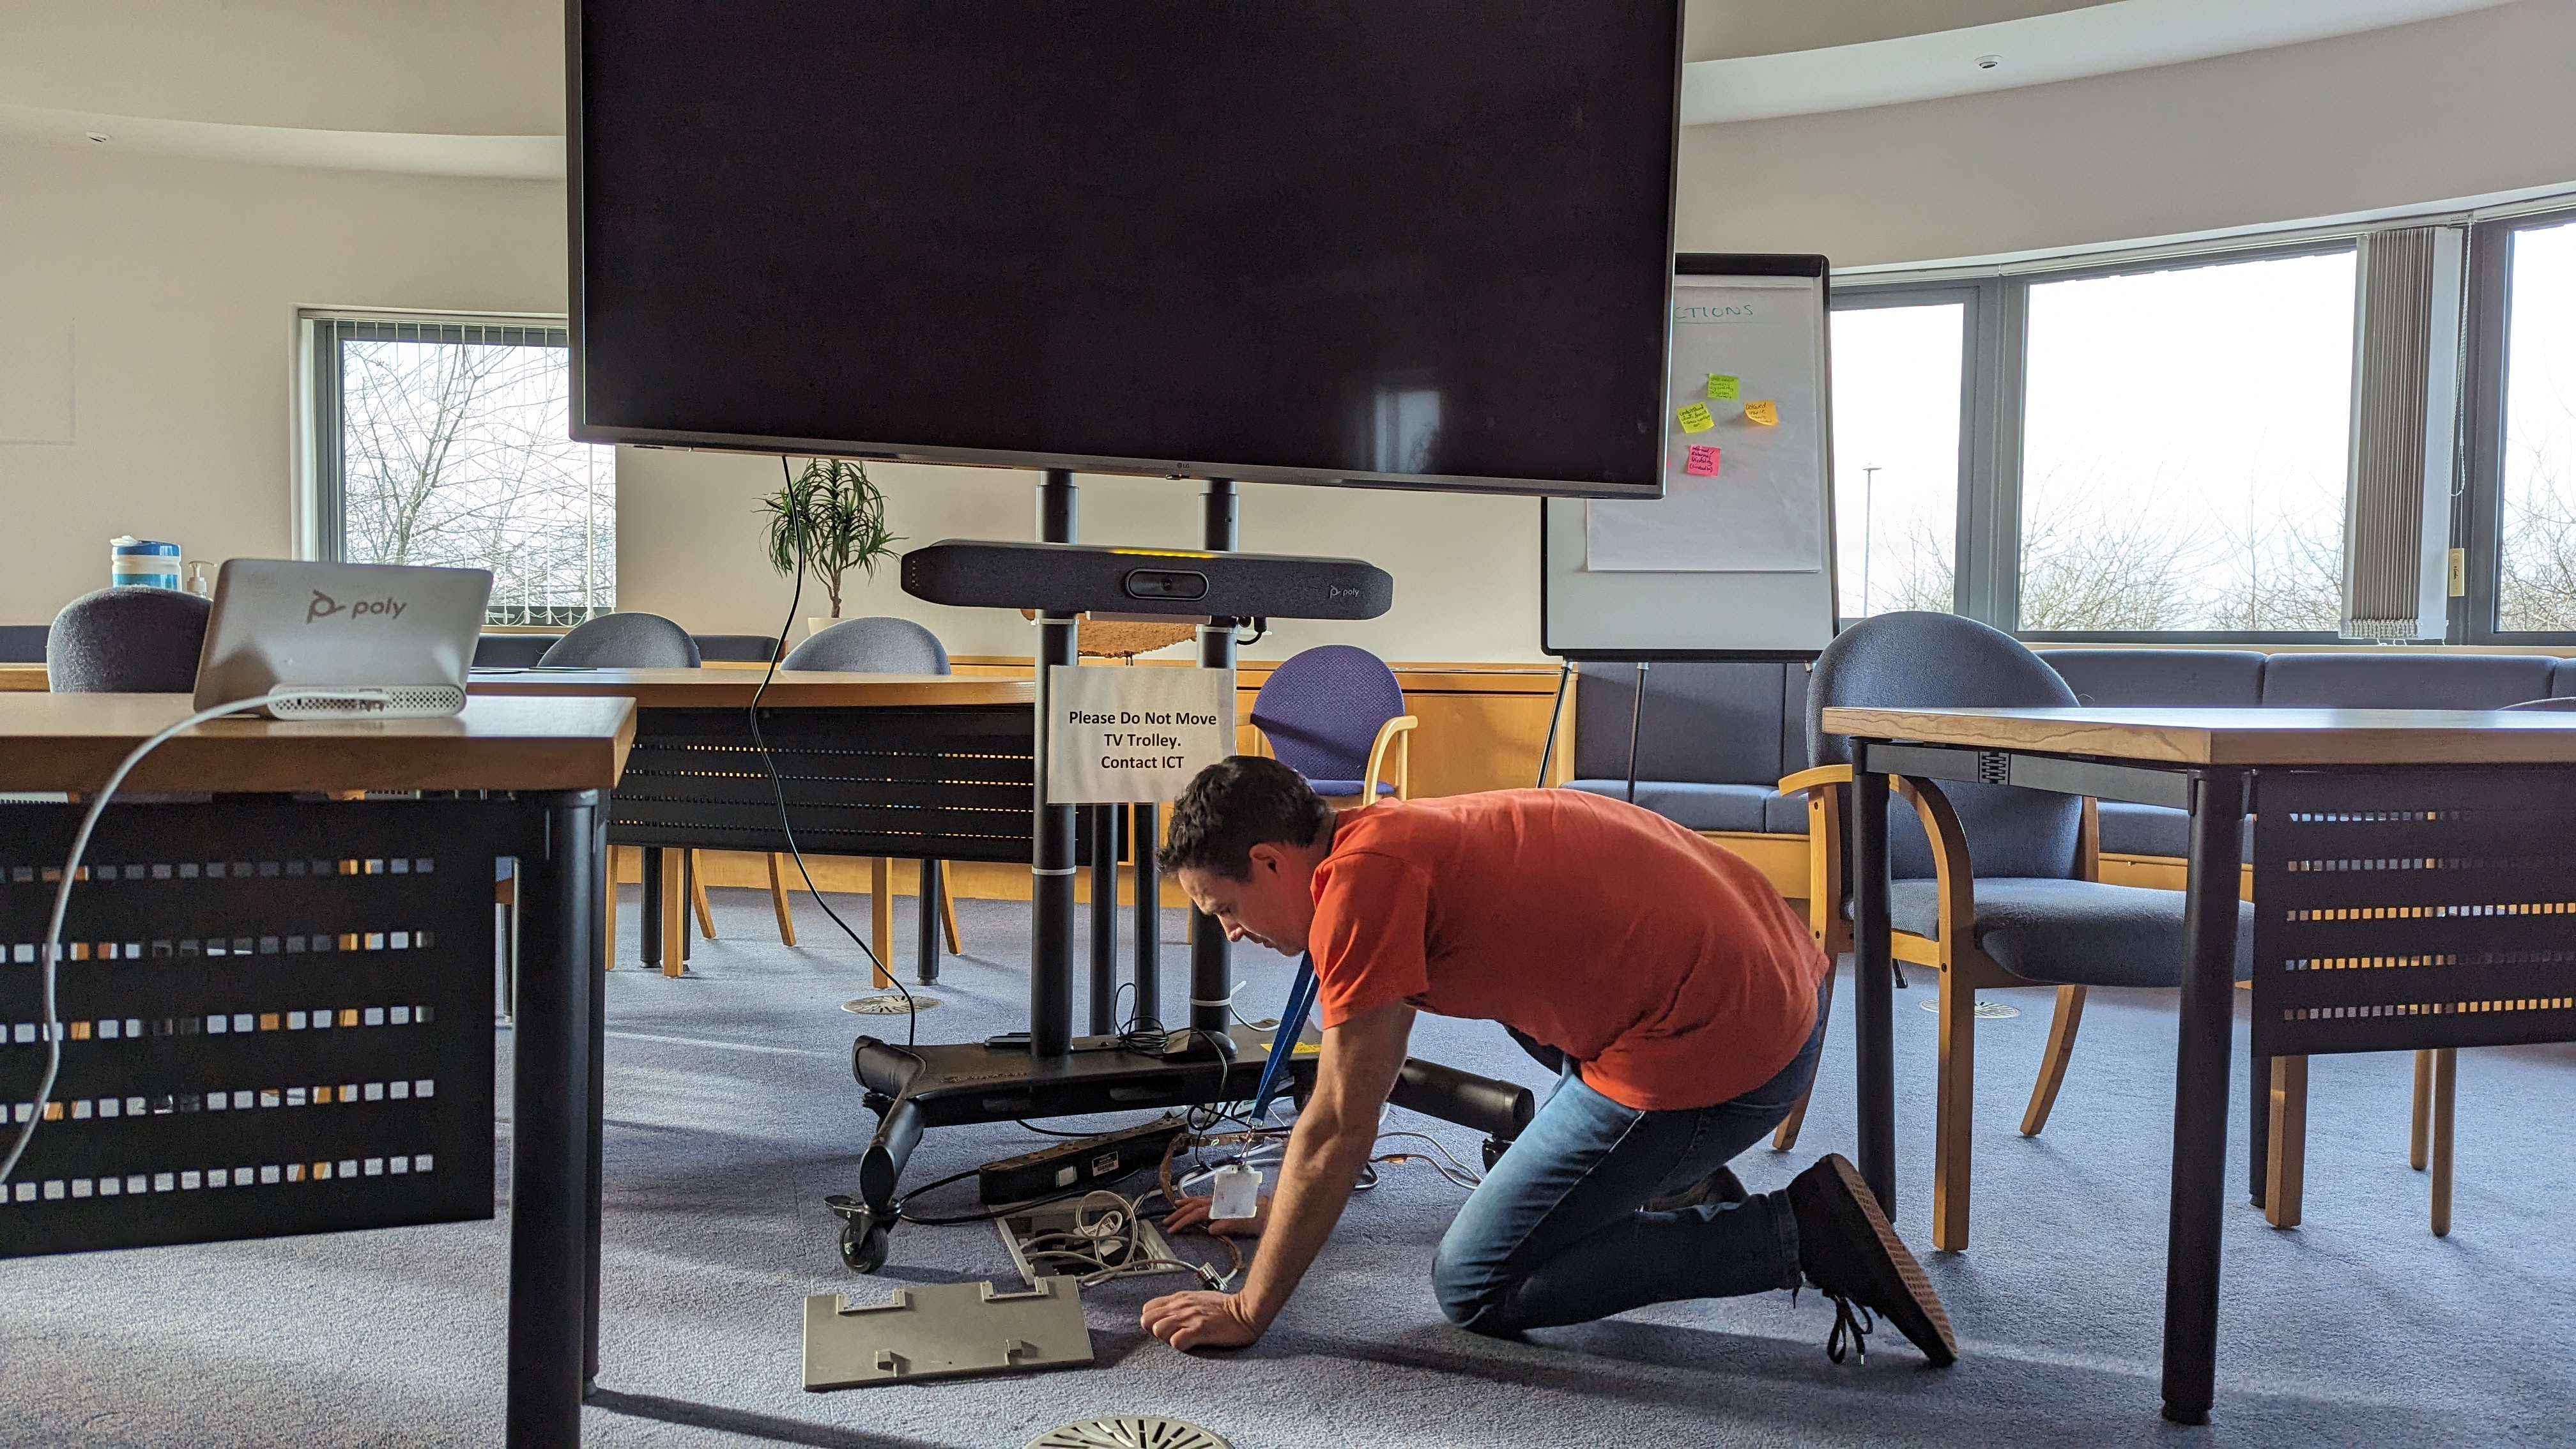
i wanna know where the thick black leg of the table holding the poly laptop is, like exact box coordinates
[507,792,600,1446]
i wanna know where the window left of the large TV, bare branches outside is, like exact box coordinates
[307,314,618,624]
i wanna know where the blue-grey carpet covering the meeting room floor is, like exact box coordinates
[0,889,2576,1449]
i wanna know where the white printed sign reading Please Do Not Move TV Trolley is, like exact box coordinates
[1046,665,1234,804]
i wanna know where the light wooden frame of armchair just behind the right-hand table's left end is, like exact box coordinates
[1772,766,2102,1253]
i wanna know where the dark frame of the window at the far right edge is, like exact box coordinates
[2450,206,2576,647]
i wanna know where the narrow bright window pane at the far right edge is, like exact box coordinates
[2496,222,2576,632]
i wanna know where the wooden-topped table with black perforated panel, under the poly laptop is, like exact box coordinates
[0,694,634,1444]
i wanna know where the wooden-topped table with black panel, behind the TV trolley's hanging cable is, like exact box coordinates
[469,668,1036,985]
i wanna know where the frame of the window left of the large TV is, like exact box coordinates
[294,307,616,629]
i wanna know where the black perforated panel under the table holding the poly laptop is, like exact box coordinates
[0,797,512,1253]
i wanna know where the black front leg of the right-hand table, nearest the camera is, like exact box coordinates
[2164,771,2246,1423]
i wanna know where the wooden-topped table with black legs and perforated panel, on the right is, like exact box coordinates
[1824,709,2576,1423]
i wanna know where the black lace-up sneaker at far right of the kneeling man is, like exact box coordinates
[1788,1153,1958,1369]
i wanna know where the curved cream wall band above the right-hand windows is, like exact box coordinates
[1682,0,2576,266]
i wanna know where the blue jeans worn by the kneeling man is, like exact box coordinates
[1432,993,1824,1333]
